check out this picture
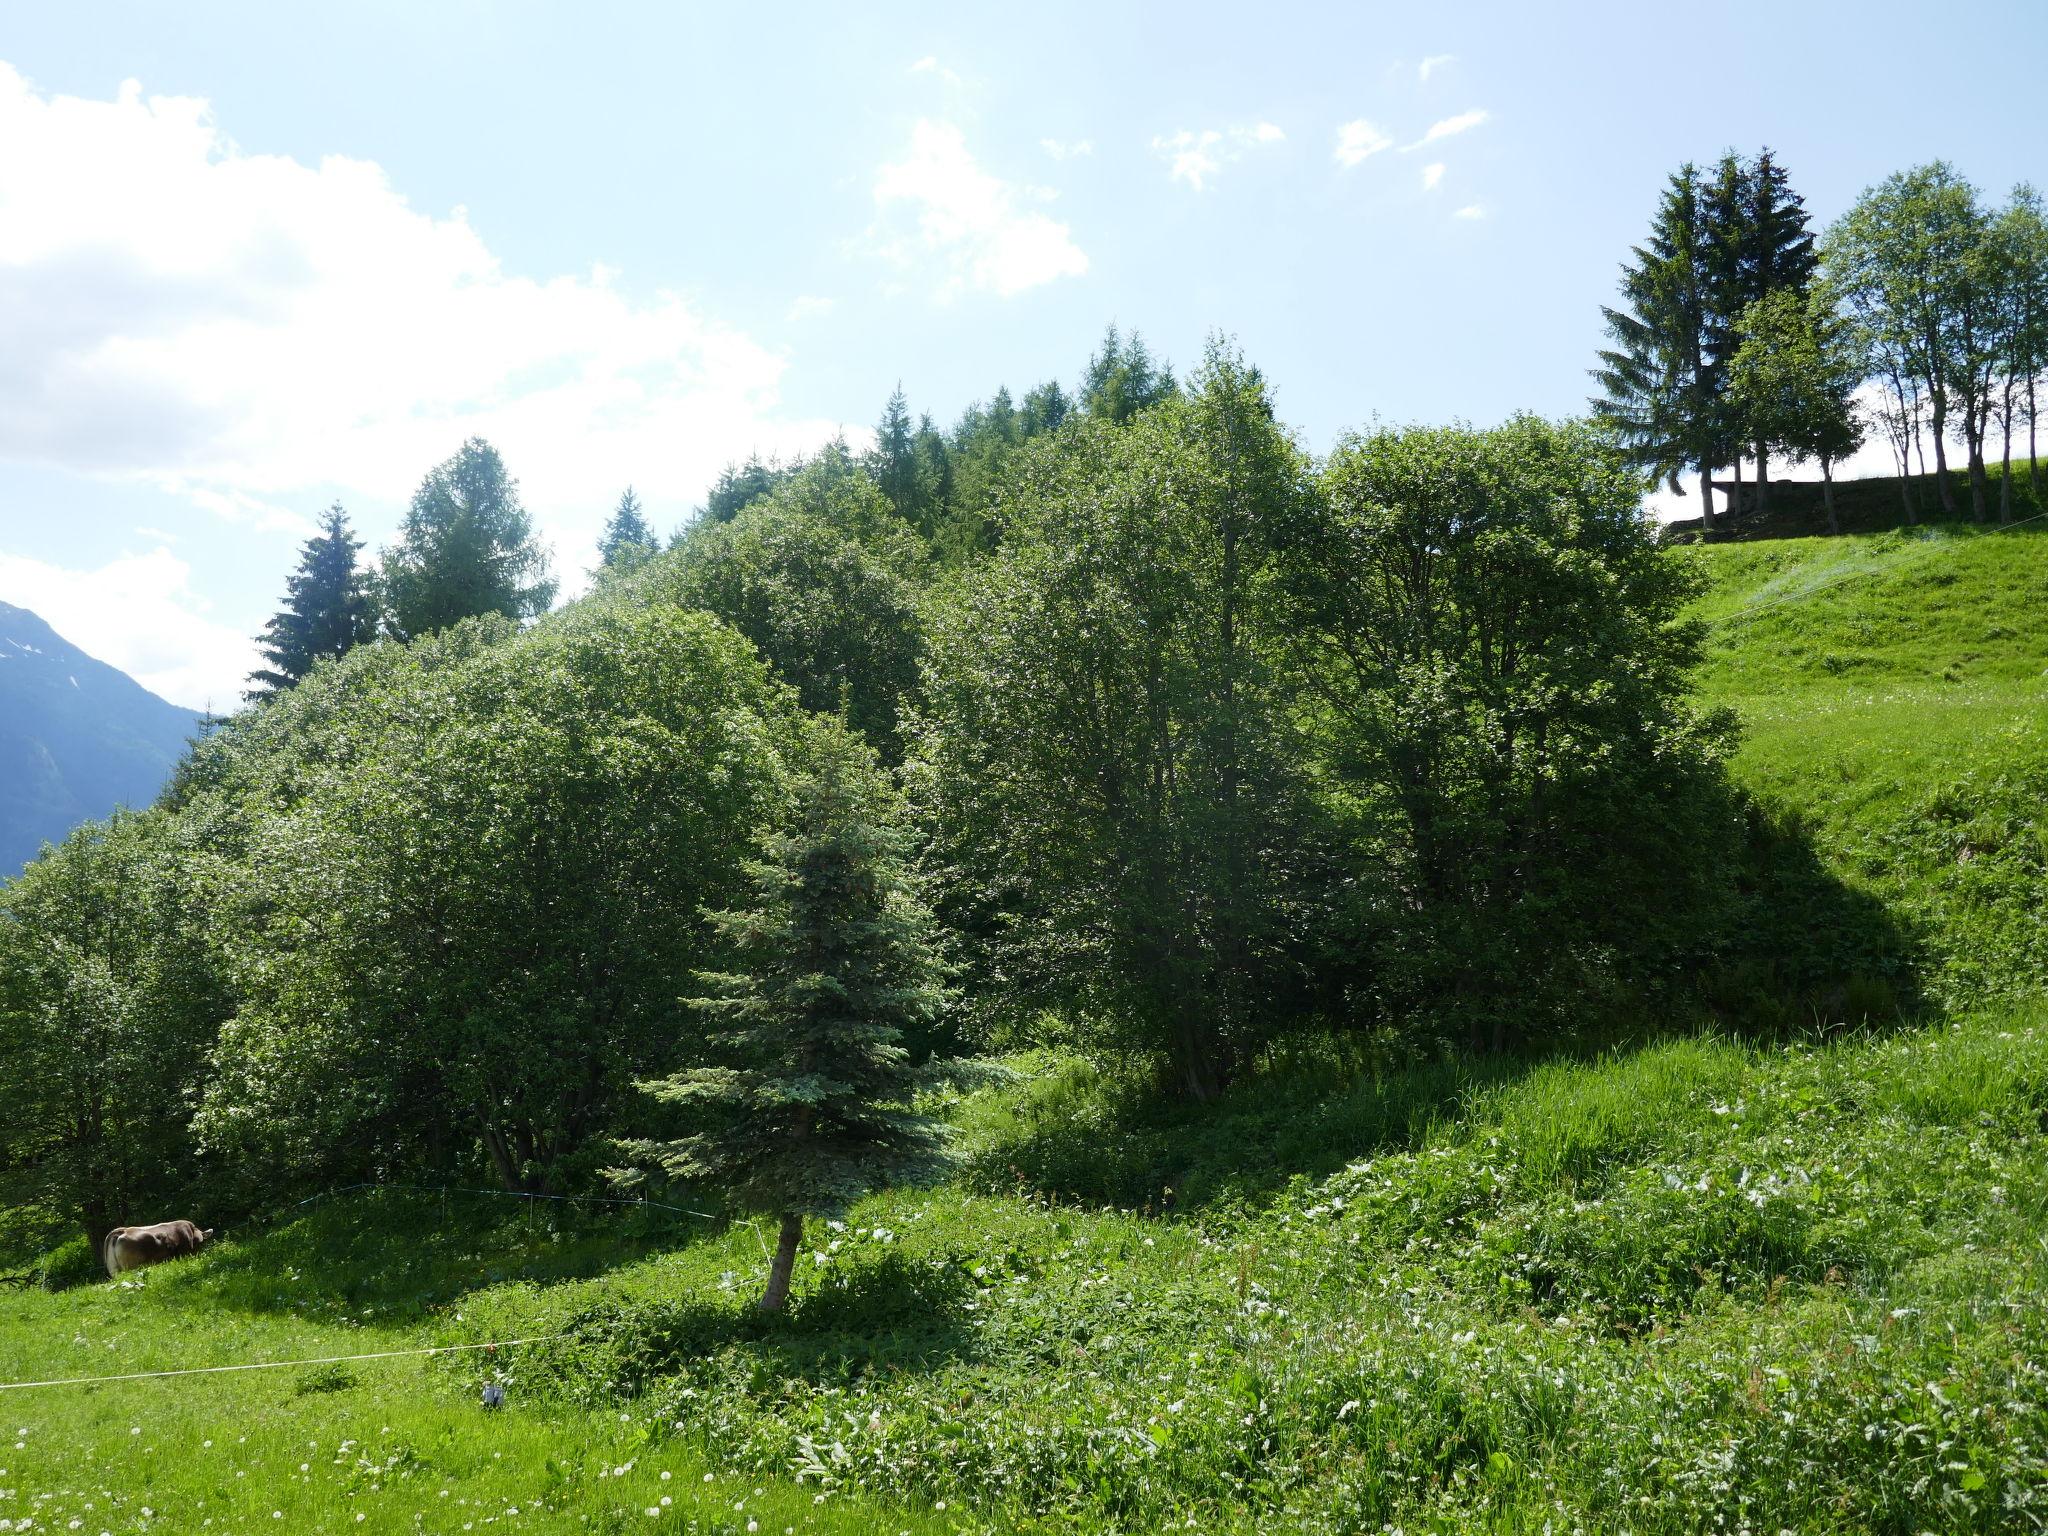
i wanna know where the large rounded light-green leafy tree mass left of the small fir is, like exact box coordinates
[199,602,788,1188]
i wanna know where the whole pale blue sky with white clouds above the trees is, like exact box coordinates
[0,0,2048,709]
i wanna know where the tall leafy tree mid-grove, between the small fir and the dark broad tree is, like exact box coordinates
[920,344,1305,1098]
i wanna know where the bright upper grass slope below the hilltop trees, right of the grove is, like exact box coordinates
[1688,522,2048,1006]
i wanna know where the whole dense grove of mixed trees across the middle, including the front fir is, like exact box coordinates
[0,315,1892,1305]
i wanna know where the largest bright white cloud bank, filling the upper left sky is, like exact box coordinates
[0,63,856,581]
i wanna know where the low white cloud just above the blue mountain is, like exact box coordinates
[0,545,258,713]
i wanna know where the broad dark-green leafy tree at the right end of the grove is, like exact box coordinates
[1276,418,1733,1049]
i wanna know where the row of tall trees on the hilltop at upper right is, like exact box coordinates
[1591,150,2048,537]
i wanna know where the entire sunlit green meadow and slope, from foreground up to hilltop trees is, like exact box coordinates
[0,528,2048,1536]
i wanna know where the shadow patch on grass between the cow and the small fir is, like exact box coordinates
[158,1190,717,1323]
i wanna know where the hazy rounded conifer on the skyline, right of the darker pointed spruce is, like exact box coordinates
[383,438,555,639]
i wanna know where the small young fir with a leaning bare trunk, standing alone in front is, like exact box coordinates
[629,717,944,1313]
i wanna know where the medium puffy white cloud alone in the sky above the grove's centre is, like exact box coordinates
[868,119,1087,299]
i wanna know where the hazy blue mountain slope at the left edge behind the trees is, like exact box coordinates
[0,602,199,879]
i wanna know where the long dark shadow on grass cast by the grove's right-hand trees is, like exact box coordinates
[967,799,1925,1214]
